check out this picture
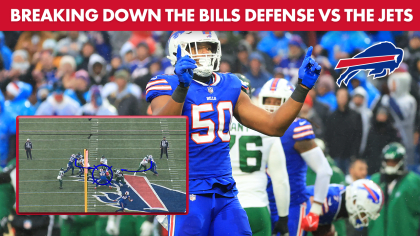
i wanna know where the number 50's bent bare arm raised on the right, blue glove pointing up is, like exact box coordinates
[234,46,321,136]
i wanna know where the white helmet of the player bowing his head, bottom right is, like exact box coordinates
[346,179,384,228]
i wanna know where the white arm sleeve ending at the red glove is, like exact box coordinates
[300,147,332,208]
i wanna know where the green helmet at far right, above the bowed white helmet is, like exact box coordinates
[381,142,405,175]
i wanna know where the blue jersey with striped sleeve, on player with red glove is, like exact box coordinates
[281,118,315,205]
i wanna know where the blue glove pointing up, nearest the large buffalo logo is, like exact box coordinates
[299,46,321,89]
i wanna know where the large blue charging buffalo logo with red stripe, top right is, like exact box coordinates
[335,42,404,86]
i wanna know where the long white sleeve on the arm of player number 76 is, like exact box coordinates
[268,138,290,217]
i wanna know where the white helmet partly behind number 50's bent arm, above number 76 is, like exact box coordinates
[258,78,295,112]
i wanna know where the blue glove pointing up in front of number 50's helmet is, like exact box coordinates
[175,45,197,87]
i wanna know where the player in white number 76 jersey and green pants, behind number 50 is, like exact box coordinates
[230,74,290,236]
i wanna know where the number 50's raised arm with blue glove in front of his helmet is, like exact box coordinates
[151,45,197,116]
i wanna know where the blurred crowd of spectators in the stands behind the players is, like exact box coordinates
[0,31,420,235]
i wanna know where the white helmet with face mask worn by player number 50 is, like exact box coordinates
[167,31,222,77]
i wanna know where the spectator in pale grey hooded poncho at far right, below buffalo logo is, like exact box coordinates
[380,71,417,166]
